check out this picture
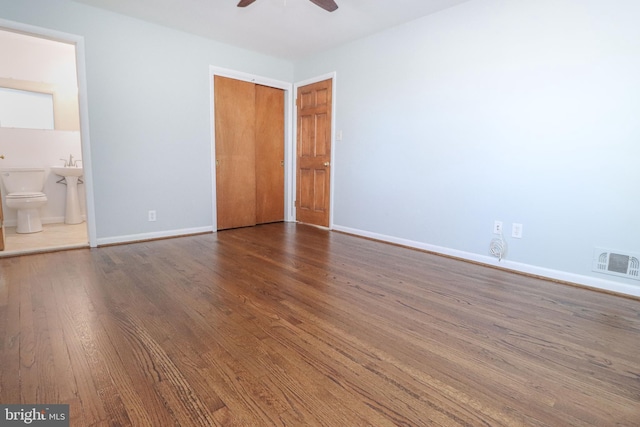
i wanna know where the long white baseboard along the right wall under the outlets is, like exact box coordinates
[332,224,640,297]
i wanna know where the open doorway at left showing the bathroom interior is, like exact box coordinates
[0,20,95,257]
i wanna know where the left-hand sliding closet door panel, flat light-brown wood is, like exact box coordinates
[214,76,256,230]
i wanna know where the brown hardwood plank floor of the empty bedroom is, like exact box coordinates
[0,223,640,427]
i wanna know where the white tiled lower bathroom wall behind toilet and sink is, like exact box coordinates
[0,128,86,227]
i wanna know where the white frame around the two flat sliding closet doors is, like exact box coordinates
[209,65,295,231]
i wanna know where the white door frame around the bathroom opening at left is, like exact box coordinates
[0,19,98,248]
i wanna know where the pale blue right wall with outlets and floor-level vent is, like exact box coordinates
[295,0,640,294]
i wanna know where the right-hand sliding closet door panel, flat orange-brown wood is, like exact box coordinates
[256,85,284,224]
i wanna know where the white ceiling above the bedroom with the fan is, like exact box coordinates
[74,0,470,60]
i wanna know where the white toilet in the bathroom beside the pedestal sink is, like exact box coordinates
[0,168,47,233]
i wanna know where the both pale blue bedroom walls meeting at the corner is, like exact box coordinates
[0,0,640,294]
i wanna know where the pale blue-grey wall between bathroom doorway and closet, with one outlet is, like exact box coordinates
[0,0,293,243]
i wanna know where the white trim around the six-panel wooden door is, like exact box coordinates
[294,71,337,230]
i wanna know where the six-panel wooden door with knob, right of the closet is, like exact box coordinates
[296,80,332,227]
